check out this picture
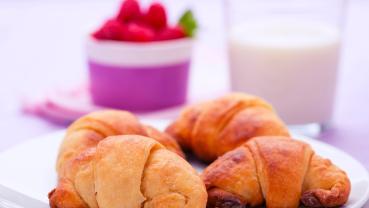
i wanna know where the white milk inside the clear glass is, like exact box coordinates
[229,20,340,124]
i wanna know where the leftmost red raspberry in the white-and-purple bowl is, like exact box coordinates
[92,20,126,40]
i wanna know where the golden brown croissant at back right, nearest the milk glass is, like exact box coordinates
[166,93,289,162]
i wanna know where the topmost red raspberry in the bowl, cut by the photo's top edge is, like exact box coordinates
[117,0,141,23]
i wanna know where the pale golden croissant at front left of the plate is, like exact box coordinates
[49,135,207,208]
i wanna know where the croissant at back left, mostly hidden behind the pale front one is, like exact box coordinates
[50,110,188,208]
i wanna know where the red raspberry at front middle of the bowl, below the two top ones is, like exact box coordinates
[124,23,155,42]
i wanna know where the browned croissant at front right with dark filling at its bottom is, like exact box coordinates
[202,136,350,208]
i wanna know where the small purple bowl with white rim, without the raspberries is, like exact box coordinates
[87,38,192,111]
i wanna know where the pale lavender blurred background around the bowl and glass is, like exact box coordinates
[0,0,369,168]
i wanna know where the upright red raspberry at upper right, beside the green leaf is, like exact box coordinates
[145,3,167,30]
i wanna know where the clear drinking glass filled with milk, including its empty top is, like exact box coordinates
[225,0,345,125]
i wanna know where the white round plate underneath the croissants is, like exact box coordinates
[0,120,369,208]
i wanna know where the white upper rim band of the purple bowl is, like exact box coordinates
[86,37,194,67]
